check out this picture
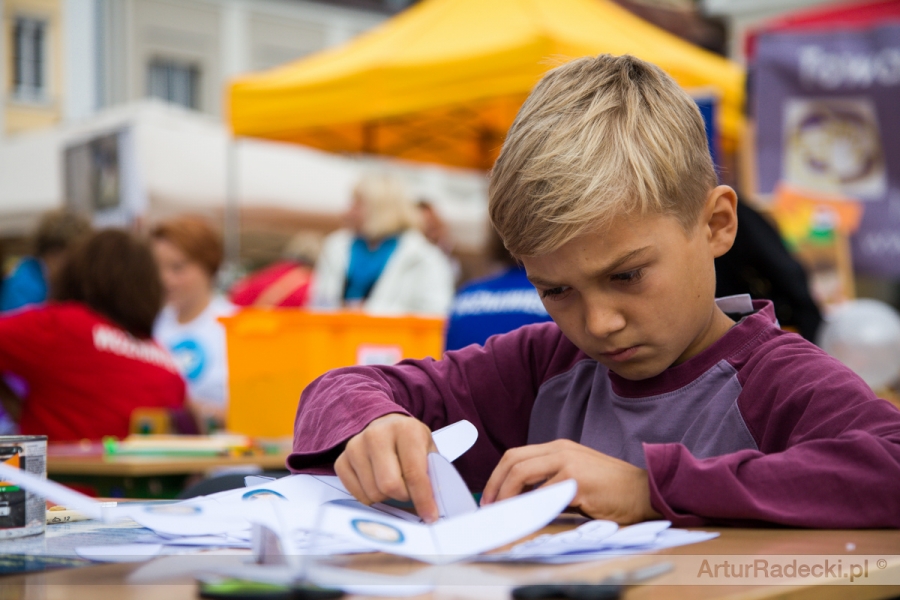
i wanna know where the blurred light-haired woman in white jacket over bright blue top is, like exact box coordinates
[312,173,454,316]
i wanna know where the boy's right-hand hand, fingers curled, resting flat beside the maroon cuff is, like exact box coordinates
[481,440,661,525]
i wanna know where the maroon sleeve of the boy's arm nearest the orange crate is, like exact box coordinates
[288,323,574,490]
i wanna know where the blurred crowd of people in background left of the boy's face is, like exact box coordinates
[0,173,549,442]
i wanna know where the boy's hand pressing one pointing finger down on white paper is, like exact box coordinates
[334,413,438,523]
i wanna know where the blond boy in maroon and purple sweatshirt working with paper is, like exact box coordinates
[289,56,900,527]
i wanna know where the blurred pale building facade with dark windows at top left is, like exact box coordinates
[0,0,410,135]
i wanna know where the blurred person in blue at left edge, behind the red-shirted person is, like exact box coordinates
[0,210,91,312]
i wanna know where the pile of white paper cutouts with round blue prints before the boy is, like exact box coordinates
[7,422,717,574]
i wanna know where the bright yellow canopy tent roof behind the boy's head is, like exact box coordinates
[229,0,744,169]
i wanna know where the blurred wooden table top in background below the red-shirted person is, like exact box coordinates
[47,444,288,477]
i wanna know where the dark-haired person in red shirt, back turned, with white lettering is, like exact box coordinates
[0,229,185,442]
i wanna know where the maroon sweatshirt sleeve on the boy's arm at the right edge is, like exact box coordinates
[644,338,900,529]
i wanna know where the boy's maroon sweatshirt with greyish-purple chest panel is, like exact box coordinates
[288,301,900,528]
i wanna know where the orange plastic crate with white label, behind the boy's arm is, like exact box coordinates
[220,308,444,437]
